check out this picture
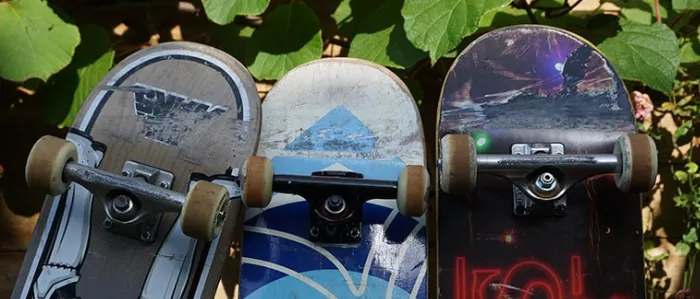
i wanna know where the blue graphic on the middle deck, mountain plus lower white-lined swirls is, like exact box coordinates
[240,102,427,299]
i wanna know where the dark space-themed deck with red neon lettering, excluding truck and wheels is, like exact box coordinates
[438,25,644,299]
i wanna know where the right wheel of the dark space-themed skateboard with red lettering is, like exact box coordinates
[614,134,658,193]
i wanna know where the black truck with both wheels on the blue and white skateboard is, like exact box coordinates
[239,156,430,244]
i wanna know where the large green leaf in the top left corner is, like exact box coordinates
[0,0,80,82]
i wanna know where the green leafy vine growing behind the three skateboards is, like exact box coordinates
[0,0,700,296]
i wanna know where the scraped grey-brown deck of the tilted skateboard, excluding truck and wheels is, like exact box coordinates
[13,42,261,298]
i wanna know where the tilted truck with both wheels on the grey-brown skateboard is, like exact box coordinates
[25,136,229,242]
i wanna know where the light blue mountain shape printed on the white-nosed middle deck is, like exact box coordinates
[284,106,377,153]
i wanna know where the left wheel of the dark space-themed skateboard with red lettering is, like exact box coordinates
[440,134,476,195]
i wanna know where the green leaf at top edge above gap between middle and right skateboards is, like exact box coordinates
[401,0,510,64]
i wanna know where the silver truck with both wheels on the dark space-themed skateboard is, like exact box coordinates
[439,134,657,216]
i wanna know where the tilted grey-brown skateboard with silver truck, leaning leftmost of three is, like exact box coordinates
[12,42,261,299]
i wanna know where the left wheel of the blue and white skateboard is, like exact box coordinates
[241,156,274,208]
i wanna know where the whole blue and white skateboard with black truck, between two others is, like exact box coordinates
[239,58,430,299]
